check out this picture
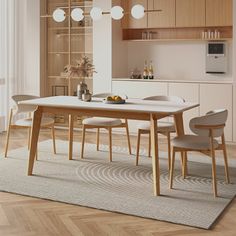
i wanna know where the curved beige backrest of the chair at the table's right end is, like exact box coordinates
[189,109,228,138]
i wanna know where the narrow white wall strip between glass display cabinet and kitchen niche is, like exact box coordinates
[93,0,112,94]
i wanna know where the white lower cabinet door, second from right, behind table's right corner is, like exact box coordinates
[169,83,199,134]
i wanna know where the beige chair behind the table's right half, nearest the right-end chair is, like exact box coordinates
[136,96,184,170]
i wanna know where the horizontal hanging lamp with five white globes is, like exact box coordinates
[45,4,162,22]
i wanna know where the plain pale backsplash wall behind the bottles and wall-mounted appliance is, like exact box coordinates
[127,41,232,80]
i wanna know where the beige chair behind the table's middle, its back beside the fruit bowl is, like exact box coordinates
[81,93,131,161]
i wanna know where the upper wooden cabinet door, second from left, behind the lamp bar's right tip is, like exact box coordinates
[148,0,175,28]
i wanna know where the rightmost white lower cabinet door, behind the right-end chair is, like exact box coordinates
[200,84,233,141]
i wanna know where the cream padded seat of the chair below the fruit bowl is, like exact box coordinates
[83,117,122,127]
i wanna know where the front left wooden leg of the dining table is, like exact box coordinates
[28,107,42,175]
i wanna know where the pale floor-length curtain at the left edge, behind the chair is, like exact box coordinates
[0,0,40,131]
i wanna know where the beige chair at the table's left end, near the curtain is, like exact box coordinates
[5,95,56,159]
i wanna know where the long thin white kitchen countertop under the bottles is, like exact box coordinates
[112,78,234,84]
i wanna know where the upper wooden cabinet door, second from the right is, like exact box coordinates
[176,0,206,27]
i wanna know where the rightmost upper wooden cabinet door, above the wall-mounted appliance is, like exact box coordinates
[206,0,233,26]
